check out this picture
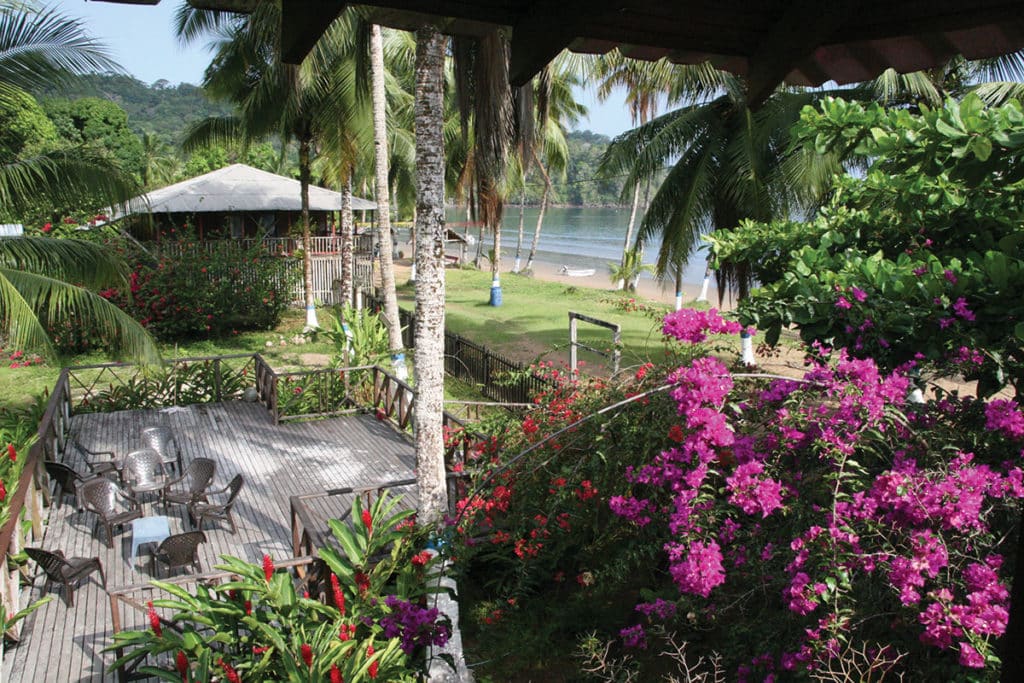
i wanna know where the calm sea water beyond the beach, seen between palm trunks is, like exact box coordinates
[446,206,705,285]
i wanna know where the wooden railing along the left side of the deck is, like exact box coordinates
[0,369,72,652]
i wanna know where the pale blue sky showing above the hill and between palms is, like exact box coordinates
[56,0,632,137]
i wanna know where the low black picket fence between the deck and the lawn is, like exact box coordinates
[366,296,551,403]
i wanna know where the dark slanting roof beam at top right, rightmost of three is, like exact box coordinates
[746,0,862,106]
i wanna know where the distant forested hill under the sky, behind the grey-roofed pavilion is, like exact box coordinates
[33,74,231,144]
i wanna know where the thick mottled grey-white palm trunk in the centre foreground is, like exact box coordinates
[415,29,447,526]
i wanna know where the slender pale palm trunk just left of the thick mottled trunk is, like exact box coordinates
[370,24,409,380]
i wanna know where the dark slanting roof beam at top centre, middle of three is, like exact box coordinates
[509,0,622,87]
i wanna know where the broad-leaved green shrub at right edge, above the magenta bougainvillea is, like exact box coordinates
[709,95,1024,395]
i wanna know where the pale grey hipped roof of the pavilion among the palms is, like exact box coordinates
[119,164,377,217]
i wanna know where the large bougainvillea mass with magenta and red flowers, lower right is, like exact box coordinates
[457,316,1024,681]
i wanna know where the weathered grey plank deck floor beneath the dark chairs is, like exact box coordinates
[2,402,415,683]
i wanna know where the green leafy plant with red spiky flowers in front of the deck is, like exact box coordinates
[108,496,451,683]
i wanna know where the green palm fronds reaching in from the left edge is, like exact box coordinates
[0,0,160,361]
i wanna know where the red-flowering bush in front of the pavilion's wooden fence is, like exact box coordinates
[100,230,291,340]
